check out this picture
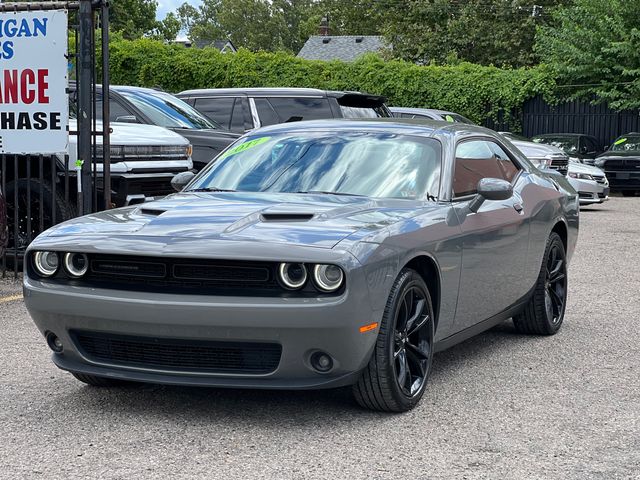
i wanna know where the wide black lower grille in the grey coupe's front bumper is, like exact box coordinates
[71,331,282,375]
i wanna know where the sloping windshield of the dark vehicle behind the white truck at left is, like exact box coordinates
[117,90,222,129]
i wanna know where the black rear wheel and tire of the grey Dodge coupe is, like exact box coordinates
[513,232,567,335]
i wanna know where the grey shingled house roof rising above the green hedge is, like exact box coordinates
[298,35,384,62]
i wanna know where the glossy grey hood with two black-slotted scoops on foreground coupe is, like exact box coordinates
[47,192,435,248]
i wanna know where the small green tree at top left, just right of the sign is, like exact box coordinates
[109,0,158,39]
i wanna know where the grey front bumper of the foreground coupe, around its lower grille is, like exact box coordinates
[24,275,382,389]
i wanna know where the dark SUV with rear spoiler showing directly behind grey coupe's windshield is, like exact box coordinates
[178,88,391,133]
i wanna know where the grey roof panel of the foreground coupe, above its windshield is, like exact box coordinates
[239,118,499,139]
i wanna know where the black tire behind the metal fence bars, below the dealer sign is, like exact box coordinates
[5,178,76,250]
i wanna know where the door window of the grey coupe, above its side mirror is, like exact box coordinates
[453,140,520,197]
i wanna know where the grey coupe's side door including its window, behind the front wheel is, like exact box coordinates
[452,138,530,330]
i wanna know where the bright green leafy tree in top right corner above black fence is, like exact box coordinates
[536,0,640,109]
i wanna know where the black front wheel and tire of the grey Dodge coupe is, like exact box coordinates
[353,268,435,412]
